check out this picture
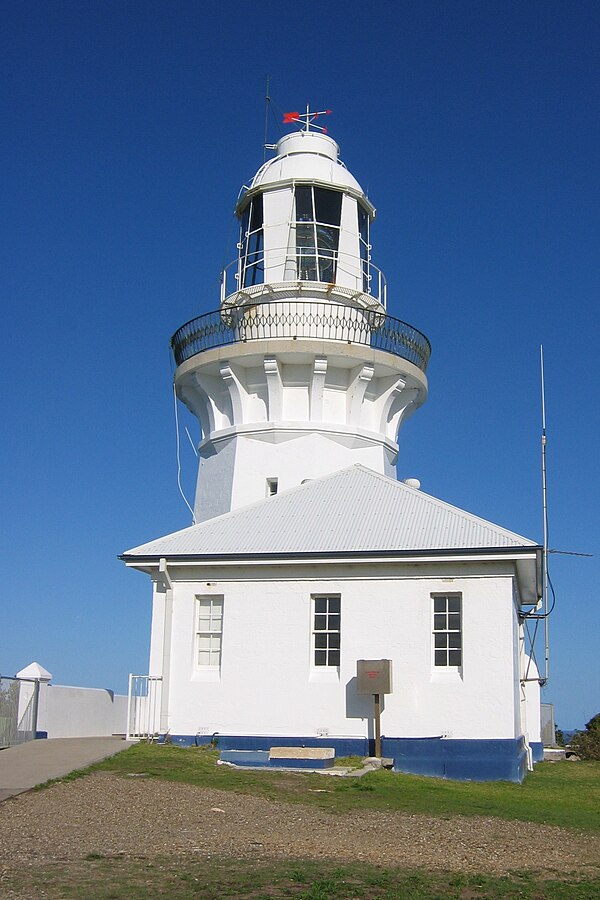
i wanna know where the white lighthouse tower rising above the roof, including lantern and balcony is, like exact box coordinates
[172,113,430,522]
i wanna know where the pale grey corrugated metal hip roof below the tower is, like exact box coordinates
[123,464,537,558]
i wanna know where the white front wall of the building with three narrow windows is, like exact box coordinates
[153,563,521,738]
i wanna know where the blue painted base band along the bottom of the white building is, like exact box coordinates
[163,734,528,783]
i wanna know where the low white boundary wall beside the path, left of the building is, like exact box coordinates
[37,683,127,738]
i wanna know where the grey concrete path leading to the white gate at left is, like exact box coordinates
[0,737,131,800]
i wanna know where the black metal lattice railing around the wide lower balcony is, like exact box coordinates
[171,300,431,372]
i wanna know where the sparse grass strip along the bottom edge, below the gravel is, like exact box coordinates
[4,858,600,900]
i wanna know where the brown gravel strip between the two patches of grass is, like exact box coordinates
[0,773,600,875]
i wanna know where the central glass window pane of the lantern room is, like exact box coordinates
[295,185,342,284]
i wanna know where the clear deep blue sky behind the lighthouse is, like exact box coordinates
[0,0,600,728]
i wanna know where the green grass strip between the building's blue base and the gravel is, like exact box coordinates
[92,744,600,831]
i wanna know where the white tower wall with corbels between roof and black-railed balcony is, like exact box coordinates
[184,341,426,522]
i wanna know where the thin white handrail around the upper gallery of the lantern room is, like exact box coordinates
[221,247,387,309]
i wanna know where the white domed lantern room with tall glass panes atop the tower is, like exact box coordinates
[221,130,386,310]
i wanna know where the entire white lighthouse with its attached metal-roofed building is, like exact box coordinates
[122,114,541,780]
